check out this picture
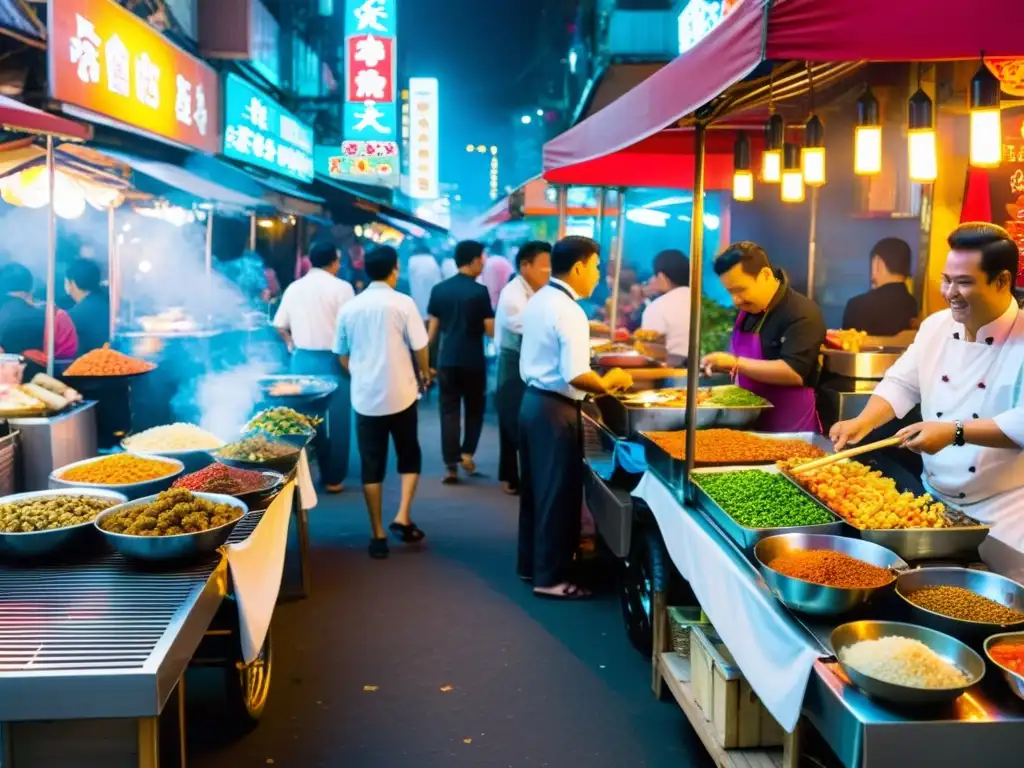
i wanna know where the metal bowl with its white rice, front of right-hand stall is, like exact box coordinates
[831,621,985,705]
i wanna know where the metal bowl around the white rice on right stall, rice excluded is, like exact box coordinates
[831,622,985,705]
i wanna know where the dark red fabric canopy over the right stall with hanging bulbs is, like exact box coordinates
[544,0,1024,188]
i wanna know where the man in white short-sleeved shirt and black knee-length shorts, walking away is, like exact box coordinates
[334,246,430,559]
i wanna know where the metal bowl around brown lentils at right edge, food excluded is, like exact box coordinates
[896,567,1024,643]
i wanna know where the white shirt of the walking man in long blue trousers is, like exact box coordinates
[273,268,355,352]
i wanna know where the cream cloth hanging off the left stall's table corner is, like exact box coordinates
[224,482,295,664]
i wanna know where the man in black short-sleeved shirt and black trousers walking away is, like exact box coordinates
[427,240,495,484]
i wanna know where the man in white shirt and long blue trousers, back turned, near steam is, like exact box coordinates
[273,242,355,494]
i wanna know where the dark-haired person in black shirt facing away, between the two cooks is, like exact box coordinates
[843,238,918,336]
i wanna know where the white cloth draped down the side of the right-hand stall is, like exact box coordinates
[633,472,820,732]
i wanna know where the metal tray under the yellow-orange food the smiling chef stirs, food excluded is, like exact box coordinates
[782,472,989,561]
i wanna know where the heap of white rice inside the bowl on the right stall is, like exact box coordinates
[840,637,968,688]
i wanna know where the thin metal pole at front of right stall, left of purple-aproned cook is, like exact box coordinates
[685,123,708,503]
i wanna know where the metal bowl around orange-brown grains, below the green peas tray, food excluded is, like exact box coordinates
[754,534,909,616]
